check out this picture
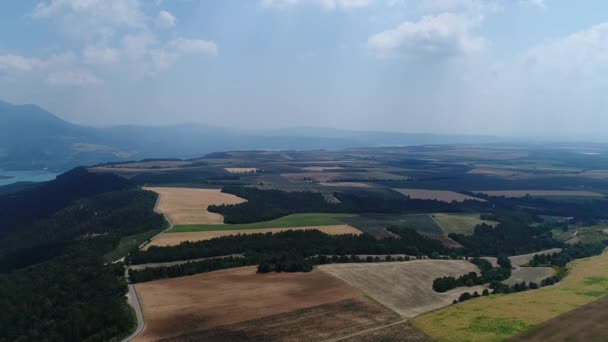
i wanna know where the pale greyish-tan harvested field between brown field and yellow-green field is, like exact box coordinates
[319,260,485,318]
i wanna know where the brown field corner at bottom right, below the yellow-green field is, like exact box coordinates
[513,297,608,342]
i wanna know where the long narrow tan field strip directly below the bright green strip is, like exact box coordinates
[145,224,362,249]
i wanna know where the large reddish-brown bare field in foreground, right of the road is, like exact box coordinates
[135,267,397,341]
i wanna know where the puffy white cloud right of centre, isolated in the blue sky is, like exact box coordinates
[367,13,485,58]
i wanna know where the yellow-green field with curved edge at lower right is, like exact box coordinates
[413,248,608,341]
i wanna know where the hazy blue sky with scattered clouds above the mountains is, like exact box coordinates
[0,0,608,140]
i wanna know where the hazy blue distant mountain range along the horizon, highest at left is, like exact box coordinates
[0,101,500,171]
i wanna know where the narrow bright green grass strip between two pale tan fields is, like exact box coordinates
[168,214,353,233]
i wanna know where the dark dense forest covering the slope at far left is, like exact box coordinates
[0,169,165,342]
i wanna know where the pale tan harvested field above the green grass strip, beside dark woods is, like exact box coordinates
[144,187,245,225]
